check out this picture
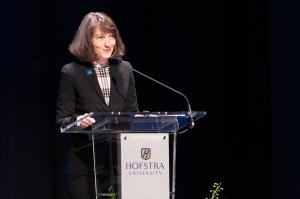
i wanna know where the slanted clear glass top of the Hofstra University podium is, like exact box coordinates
[61,111,206,133]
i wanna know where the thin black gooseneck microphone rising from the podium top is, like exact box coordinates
[122,61,195,129]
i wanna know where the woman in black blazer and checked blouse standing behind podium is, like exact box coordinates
[56,12,138,199]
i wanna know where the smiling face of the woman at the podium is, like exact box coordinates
[92,28,116,61]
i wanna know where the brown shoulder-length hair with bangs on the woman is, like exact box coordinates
[69,12,125,63]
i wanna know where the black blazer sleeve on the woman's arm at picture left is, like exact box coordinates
[56,65,76,126]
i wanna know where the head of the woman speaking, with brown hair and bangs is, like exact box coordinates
[69,12,125,63]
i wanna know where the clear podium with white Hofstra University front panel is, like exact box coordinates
[61,111,206,199]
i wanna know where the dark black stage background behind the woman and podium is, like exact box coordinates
[0,0,300,199]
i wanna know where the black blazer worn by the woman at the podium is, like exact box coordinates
[56,60,138,173]
